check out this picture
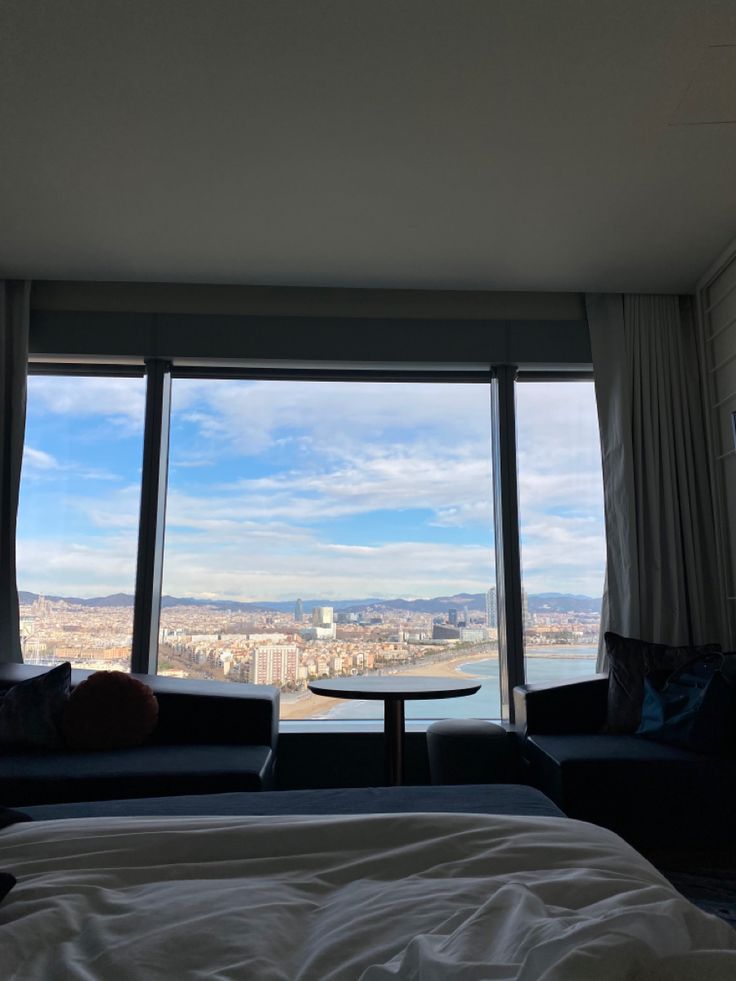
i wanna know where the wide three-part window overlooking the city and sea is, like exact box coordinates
[17,348,605,720]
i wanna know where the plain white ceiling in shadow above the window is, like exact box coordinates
[0,0,736,291]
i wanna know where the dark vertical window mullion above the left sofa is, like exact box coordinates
[131,359,171,674]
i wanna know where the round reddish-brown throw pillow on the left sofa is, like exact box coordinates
[62,671,158,749]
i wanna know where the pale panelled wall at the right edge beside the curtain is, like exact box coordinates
[698,242,736,649]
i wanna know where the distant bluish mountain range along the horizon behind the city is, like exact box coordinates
[18,590,601,613]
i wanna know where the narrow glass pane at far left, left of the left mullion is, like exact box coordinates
[17,375,145,670]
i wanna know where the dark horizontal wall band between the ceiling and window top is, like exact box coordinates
[30,282,591,368]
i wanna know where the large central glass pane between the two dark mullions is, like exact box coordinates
[159,378,499,719]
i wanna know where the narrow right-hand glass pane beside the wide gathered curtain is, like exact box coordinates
[516,381,605,683]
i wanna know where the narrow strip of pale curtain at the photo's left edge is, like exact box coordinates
[0,280,30,661]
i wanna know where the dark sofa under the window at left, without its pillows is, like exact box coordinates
[0,664,279,807]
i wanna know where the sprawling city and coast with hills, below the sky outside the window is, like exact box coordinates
[20,590,599,718]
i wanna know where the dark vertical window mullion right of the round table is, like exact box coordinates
[491,365,524,722]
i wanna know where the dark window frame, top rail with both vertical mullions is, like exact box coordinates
[21,355,593,725]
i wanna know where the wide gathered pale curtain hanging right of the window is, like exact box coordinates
[586,294,726,670]
